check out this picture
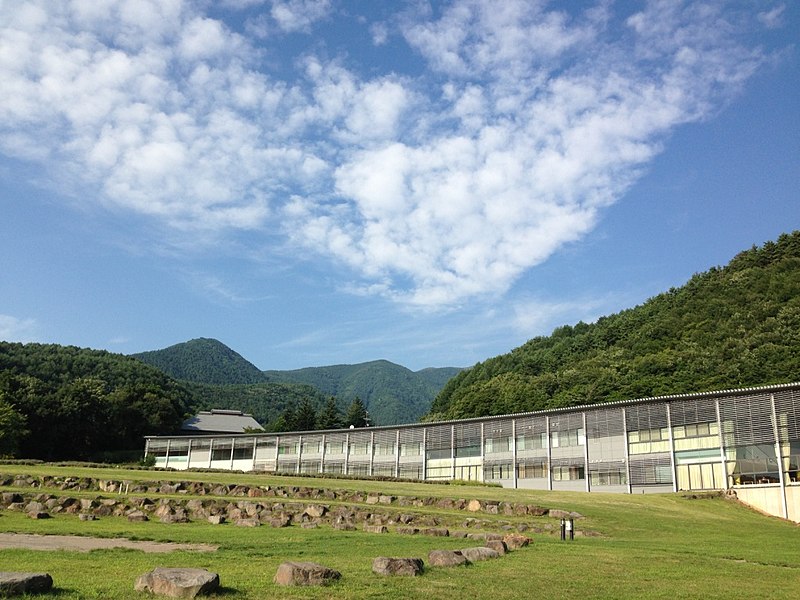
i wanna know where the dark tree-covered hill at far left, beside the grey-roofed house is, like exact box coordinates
[0,342,191,460]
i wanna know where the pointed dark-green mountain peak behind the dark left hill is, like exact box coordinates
[131,338,267,385]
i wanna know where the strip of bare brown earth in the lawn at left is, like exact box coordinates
[0,533,218,552]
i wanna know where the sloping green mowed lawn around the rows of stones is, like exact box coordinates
[0,465,800,600]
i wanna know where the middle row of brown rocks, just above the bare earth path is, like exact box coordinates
[0,492,576,539]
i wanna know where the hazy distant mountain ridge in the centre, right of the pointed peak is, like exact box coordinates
[265,360,460,425]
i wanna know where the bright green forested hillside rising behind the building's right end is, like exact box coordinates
[426,231,800,419]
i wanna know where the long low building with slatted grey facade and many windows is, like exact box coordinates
[145,383,800,522]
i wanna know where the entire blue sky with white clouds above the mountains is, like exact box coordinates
[0,0,800,370]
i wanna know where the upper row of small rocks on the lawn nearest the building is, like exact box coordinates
[0,475,568,518]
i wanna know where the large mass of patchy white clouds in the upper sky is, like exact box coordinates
[0,0,781,308]
